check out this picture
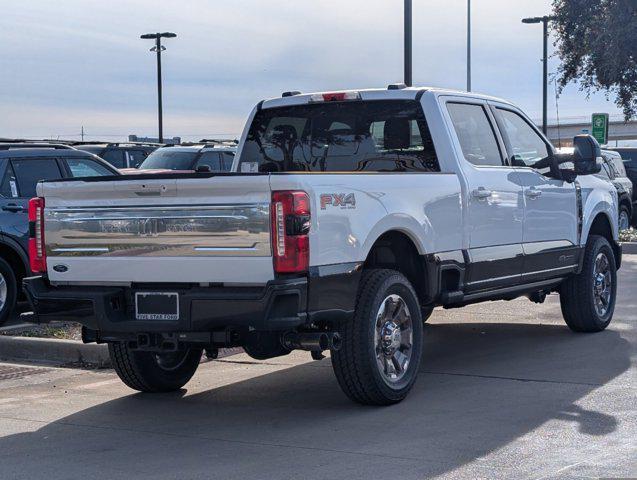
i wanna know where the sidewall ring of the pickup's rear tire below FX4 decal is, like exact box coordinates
[366,274,423,400]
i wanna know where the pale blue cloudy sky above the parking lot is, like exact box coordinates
[0,0,620,140]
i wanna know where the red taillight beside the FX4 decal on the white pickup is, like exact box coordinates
[270,190,311,273]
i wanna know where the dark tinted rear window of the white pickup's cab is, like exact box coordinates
[239,100,440,172]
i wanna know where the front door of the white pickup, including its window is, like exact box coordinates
[493,104,578,282]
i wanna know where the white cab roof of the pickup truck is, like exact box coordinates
[261,85,512,108]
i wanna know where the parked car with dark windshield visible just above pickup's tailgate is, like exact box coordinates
[122,143,237,175]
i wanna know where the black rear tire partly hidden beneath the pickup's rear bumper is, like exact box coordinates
[108,342,202,392]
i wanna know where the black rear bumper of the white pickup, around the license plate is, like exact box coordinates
[23,276,308,333]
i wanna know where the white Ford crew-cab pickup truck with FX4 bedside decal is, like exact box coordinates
[24,85,621,405]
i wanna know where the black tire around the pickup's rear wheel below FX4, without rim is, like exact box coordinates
[331,270,423,405]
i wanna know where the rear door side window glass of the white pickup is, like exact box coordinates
[447,103,502,166]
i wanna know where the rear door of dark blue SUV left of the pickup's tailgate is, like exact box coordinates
[0,158,62,250]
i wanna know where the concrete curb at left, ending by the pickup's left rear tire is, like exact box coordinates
[0,336,111,368]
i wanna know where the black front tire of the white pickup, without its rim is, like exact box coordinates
[560,235,617,332]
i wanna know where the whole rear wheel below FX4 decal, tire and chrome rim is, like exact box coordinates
[332,270,423,405]
